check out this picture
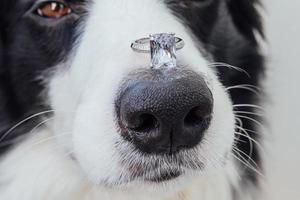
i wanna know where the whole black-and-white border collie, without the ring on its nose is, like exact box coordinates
[0,0,264,200]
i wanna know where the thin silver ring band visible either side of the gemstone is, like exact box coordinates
[131,37,184,53]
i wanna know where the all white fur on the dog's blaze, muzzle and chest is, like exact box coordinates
[0,0,237,200]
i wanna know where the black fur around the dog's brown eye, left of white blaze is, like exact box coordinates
[0,0,84,153]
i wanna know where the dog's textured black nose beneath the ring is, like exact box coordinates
[116,71,213,154]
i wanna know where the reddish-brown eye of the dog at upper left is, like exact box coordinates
[36,1,72,19]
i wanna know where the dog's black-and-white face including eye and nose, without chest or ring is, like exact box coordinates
[3,0,262,195]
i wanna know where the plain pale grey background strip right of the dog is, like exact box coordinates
[264,0,300,200]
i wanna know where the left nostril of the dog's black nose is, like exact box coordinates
[129,114,158,133]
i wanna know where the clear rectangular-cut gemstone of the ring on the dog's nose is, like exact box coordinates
[150,33,176,69]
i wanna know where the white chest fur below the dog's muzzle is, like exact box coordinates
[0,128,237,200]
